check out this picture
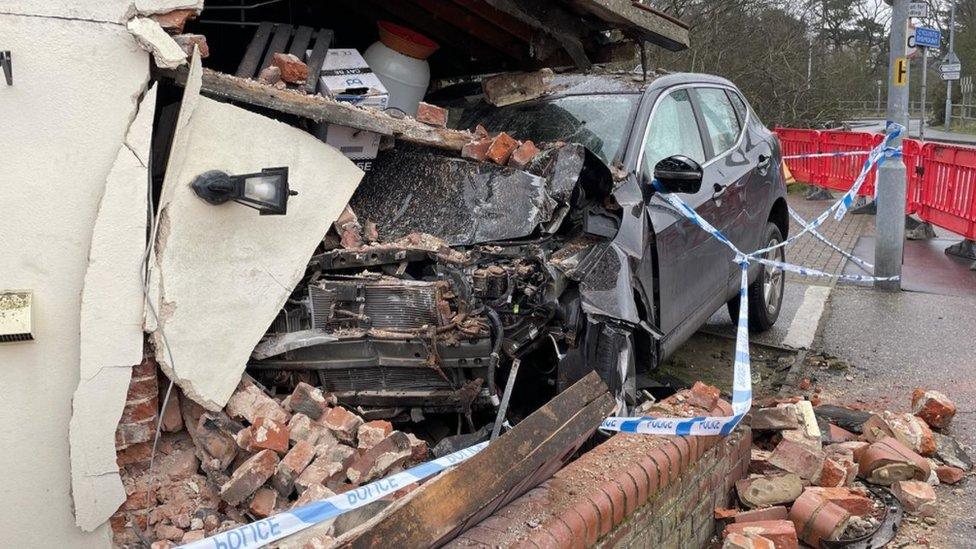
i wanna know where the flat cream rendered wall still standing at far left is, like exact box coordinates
[0,13,149,547]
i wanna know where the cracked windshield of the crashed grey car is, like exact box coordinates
[459,93,640,164]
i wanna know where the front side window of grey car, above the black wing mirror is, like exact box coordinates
[642,90,705,175]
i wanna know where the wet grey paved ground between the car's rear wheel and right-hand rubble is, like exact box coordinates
[707,186,976,547]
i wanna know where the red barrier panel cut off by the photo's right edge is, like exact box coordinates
[916,143,976,240]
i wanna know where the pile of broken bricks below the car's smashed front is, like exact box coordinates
[116,376,429,549]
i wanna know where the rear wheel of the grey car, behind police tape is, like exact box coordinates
[728,223,786,332]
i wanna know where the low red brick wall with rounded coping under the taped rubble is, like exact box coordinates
[449,427,752,548]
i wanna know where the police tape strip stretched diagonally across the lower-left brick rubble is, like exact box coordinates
[180,441,488,549]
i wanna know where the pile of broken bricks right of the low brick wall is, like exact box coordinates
[715,389,973,549]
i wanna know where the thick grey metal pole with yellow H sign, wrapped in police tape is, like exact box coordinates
[874,0,909,291]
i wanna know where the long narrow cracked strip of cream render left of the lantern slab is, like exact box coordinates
[69,83,156,531]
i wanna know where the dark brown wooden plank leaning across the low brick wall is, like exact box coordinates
[346,372,614,548]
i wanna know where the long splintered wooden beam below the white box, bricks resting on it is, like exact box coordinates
[160,68,474,151]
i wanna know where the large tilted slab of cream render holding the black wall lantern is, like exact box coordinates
[150,56,363,410]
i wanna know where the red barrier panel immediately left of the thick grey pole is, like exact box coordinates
[820,131,884,196]
